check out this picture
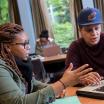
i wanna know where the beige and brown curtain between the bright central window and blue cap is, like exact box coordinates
[69,0,82,38]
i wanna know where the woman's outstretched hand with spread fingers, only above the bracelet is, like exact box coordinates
[60,63,93,87]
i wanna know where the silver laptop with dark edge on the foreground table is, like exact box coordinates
[76,80,104,99]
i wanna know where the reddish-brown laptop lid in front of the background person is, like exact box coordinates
[43,45,61,57]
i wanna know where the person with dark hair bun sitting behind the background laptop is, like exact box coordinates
[36,30,55,56]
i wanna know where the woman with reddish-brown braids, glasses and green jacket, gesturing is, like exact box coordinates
[0,23,92,104]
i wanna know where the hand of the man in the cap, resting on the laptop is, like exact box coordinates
[80,72,102,85]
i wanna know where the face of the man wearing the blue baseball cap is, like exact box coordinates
[80,24,101,46]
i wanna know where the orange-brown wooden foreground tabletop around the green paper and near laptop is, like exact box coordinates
[66,87,104,104]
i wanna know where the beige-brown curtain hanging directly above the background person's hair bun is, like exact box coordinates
[31,0,53,37]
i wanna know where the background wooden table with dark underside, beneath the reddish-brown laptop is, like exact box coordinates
[42,54,66,73]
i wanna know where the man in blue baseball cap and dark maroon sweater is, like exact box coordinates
[65,8,104,85]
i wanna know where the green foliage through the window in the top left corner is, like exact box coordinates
[0,0,10,24]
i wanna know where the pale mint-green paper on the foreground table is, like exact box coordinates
[50,96,81,104]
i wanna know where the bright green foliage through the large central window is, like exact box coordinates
[46,0,74,47]
